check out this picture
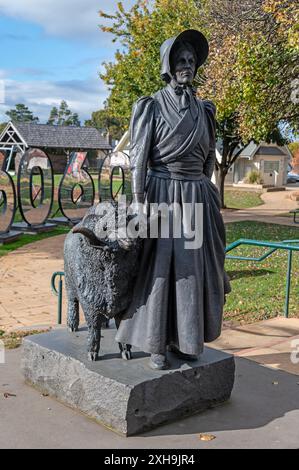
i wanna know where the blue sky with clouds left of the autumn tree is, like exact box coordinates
[0,0,135,123]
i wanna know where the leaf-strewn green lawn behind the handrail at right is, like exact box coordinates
[224,221,299,323]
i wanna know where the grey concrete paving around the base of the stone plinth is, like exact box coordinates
[0,349,299,449]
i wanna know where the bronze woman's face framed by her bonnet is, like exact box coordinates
[173,48,196,85]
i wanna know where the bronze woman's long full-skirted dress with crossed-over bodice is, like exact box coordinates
[116,85,230,355]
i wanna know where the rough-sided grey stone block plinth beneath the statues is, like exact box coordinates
[22,328,235,436]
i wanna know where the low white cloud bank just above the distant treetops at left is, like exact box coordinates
[0,79,107,124]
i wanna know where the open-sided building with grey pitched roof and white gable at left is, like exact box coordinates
[0,122,112,173]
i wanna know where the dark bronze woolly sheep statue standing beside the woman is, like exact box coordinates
[64,202,142,361]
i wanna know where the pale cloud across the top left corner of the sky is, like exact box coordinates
[0,0,135,41]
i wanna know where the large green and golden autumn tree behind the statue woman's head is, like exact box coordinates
[101,0,299,206]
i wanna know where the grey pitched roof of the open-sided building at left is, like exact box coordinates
[2,122,112,150]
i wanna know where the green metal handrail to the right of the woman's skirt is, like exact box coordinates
[225,238,299,318]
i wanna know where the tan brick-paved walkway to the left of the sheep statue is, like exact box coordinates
[0,235,65,330]
